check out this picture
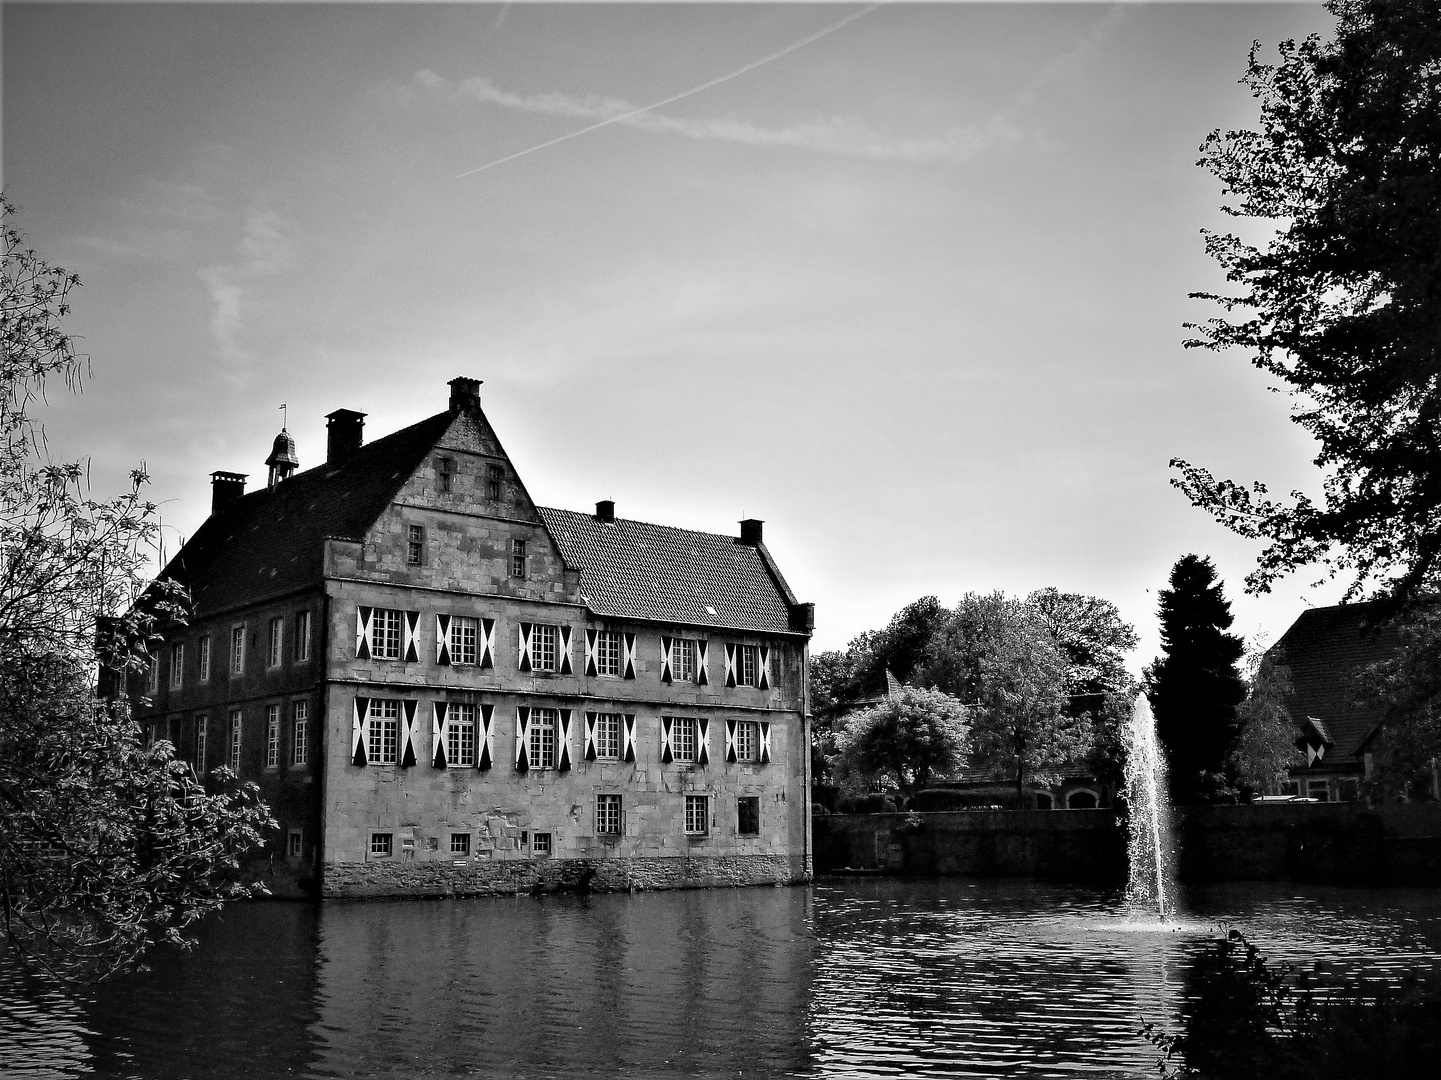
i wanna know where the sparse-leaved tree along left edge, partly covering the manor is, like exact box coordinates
[0,196,274,978]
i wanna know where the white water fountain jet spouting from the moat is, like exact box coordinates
[1125,694,1176,921]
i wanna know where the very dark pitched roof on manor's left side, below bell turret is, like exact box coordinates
[161,412,452,614]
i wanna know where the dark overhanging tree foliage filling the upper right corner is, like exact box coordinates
[1172,0,1441,601]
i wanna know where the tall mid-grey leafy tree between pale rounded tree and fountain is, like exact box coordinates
[963,594,1091,807]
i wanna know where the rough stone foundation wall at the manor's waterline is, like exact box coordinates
[321,855,810,900]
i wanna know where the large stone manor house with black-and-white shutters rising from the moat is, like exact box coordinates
[130,378,814,897]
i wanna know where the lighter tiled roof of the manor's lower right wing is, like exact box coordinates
[536,506,791,632]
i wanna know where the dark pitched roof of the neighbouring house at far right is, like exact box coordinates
[1268,603,1401,758]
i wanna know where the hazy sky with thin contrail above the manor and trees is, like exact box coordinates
[0,3,1342,673]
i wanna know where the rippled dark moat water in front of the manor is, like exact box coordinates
[0,878,1441,1080]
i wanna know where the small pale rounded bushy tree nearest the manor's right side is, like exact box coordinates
[836,686,967,799]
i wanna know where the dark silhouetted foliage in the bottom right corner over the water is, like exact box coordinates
[1141,930,1441,1080]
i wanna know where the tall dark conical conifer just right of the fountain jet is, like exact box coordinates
[1147,555,1246,805]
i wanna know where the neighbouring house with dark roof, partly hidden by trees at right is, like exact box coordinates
[1267,603,1434,802]
